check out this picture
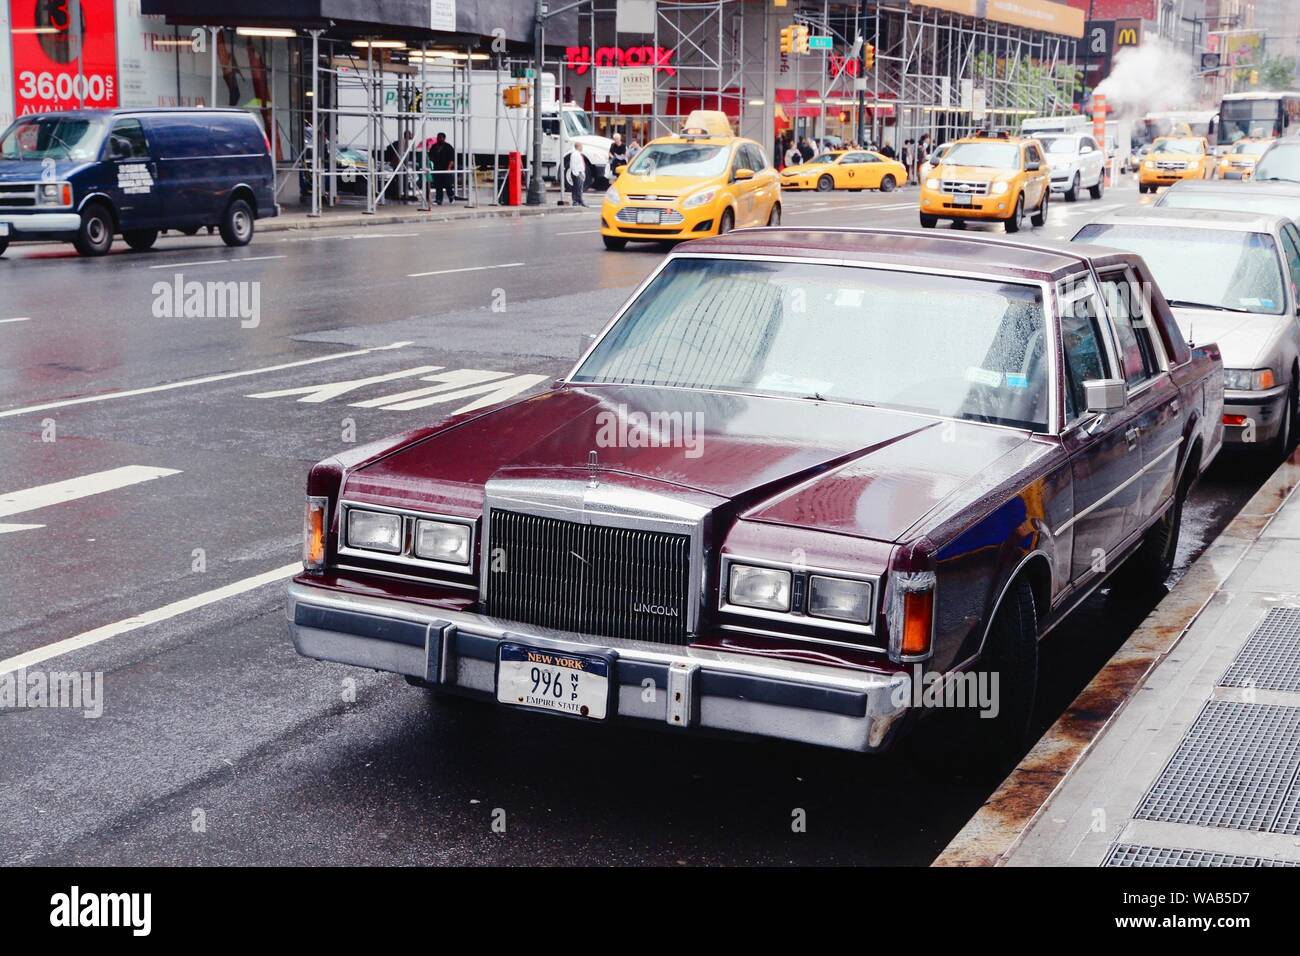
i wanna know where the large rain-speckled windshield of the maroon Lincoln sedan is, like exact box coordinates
[573,259,1050,431]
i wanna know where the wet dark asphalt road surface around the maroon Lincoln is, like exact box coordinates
[0,180,1265,865]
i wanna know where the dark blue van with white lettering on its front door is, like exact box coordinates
[0,109,280,256]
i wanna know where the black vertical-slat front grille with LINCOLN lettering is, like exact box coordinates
[485,509,690,645]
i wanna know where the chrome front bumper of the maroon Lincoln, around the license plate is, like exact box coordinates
[287,580,910,752]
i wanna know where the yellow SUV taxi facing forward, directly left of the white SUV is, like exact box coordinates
[919,135,1052,233]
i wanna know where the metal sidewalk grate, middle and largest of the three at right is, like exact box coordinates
[1134,701,1300,831]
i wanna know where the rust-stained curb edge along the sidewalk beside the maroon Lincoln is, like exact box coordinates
[931,451,1300,866]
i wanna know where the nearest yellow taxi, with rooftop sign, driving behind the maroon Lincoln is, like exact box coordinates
[601,109,781,250]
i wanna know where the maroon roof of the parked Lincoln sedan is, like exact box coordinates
[677,226,1131,280]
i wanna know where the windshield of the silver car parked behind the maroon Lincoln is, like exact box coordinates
[1074,224,1286,315]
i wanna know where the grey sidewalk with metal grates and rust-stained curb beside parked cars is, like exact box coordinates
[935,451,1300,866]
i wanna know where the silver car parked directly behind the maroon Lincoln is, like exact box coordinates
[1074,208,1300,454]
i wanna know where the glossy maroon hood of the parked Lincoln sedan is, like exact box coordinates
[343,386,1030,541]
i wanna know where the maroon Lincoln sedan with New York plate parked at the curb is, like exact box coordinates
[287,228,1223,750]
